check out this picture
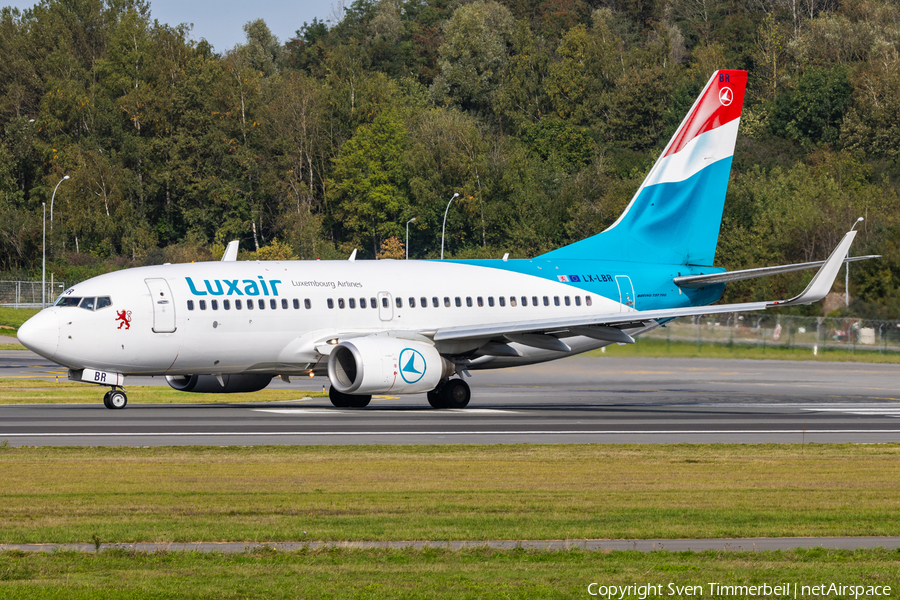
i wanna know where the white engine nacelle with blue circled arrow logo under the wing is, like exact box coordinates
[328,336,455,394]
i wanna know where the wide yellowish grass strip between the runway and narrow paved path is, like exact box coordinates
[0,440,900,543]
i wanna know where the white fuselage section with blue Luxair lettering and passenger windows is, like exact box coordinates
[22,260,631,375]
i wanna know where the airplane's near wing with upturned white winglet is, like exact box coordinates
[434,231,856,351]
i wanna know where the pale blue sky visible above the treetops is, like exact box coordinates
[0,0,334,52]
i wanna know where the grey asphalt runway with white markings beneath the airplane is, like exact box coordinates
[0,352,900,446]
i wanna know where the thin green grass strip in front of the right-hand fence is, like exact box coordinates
[588,338,900,364]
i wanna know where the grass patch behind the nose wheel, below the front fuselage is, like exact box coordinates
[0,372,328,404]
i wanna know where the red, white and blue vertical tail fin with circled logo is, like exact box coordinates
[541,71,747,266]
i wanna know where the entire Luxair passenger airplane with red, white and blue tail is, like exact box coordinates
[18,70,870,409]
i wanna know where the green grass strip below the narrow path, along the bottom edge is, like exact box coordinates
[0,548,900,600]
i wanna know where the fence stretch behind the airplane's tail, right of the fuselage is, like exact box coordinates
[640,313,900,352]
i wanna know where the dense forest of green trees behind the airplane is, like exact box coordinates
[0,0,900,319]
